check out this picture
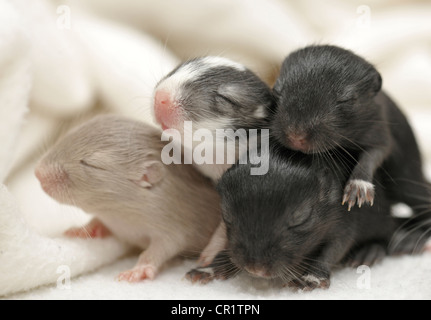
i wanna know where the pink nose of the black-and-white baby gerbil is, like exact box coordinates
[154,90,180,130]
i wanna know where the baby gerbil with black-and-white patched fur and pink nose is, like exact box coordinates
[153,57,275,265]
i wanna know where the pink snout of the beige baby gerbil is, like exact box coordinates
[34,163,69,200]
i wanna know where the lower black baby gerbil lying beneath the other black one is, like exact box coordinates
[188,144,426,290]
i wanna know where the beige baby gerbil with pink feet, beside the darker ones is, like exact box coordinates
[35,116,221,282]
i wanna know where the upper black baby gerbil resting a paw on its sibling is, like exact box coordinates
[271,45,431,222]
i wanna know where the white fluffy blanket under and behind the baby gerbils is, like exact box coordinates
[0,0,431,299]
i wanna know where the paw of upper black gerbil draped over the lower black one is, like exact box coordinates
[342,179,374,211]
